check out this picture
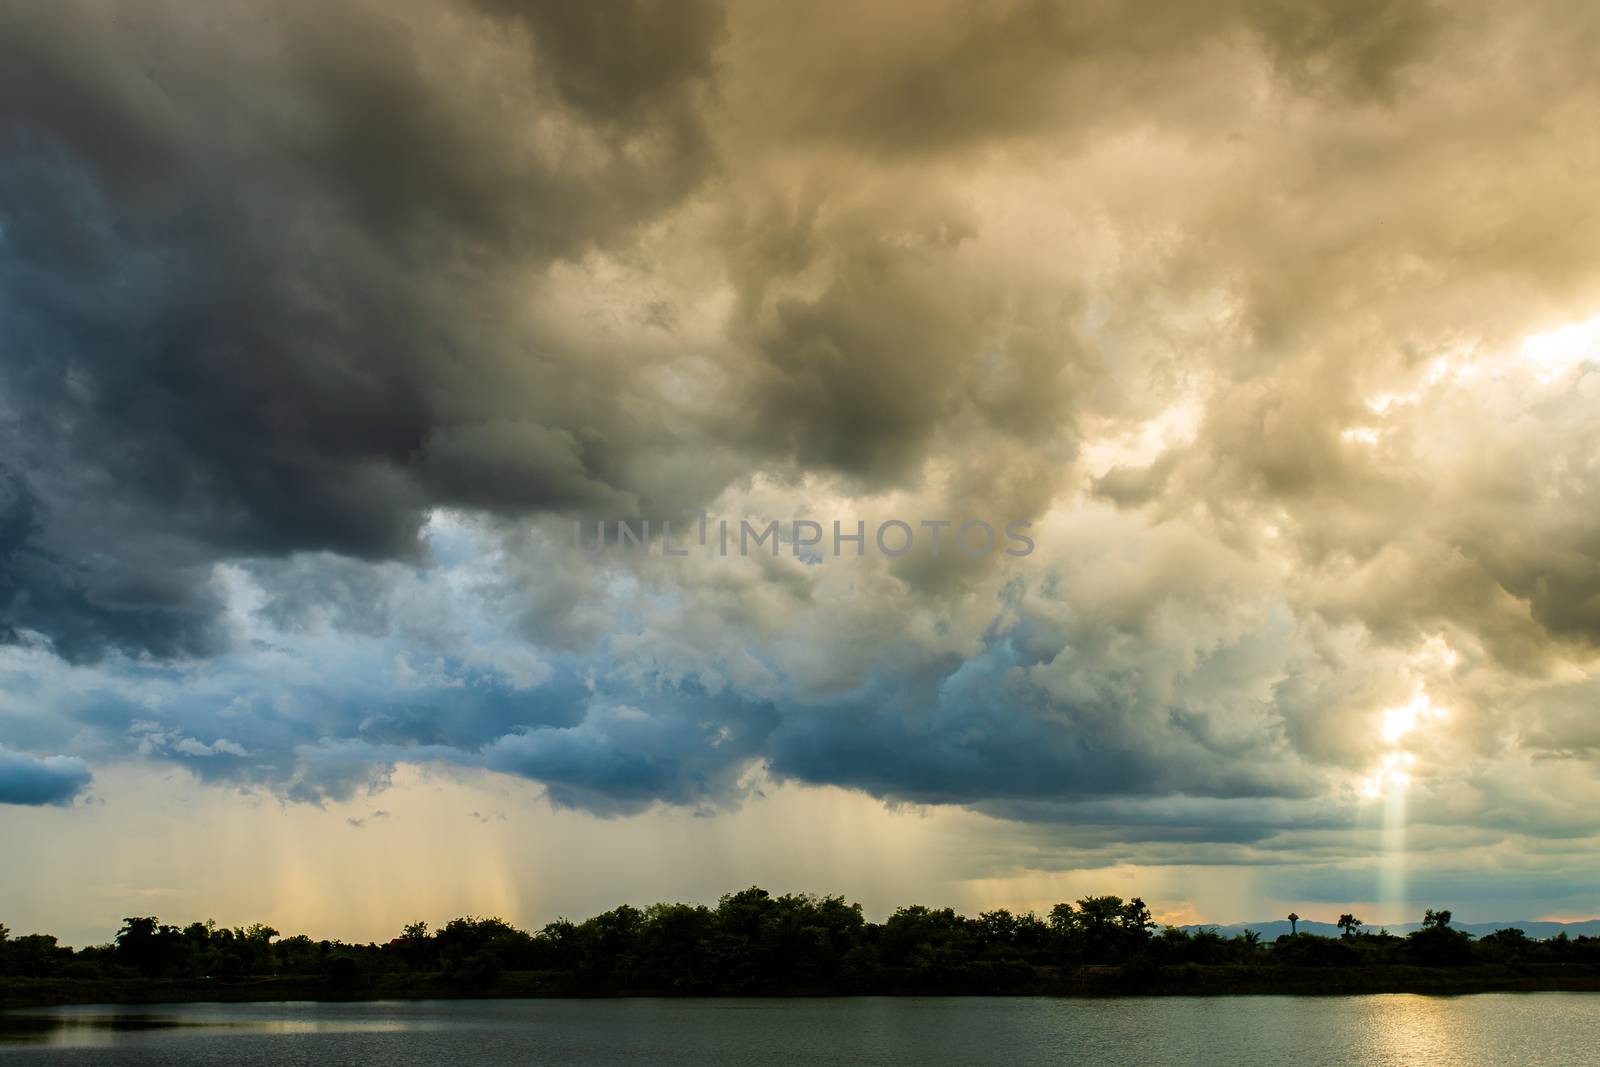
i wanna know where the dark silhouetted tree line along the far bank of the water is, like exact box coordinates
[0,886,1600,995]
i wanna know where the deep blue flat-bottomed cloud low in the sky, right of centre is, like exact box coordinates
[770,585,1325,805]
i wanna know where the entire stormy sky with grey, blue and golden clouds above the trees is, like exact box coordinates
[0,0,1600,944]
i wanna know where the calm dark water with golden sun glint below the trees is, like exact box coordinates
[0,993,1600,1067]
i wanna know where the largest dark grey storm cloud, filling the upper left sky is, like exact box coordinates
[0,3,715,657]
